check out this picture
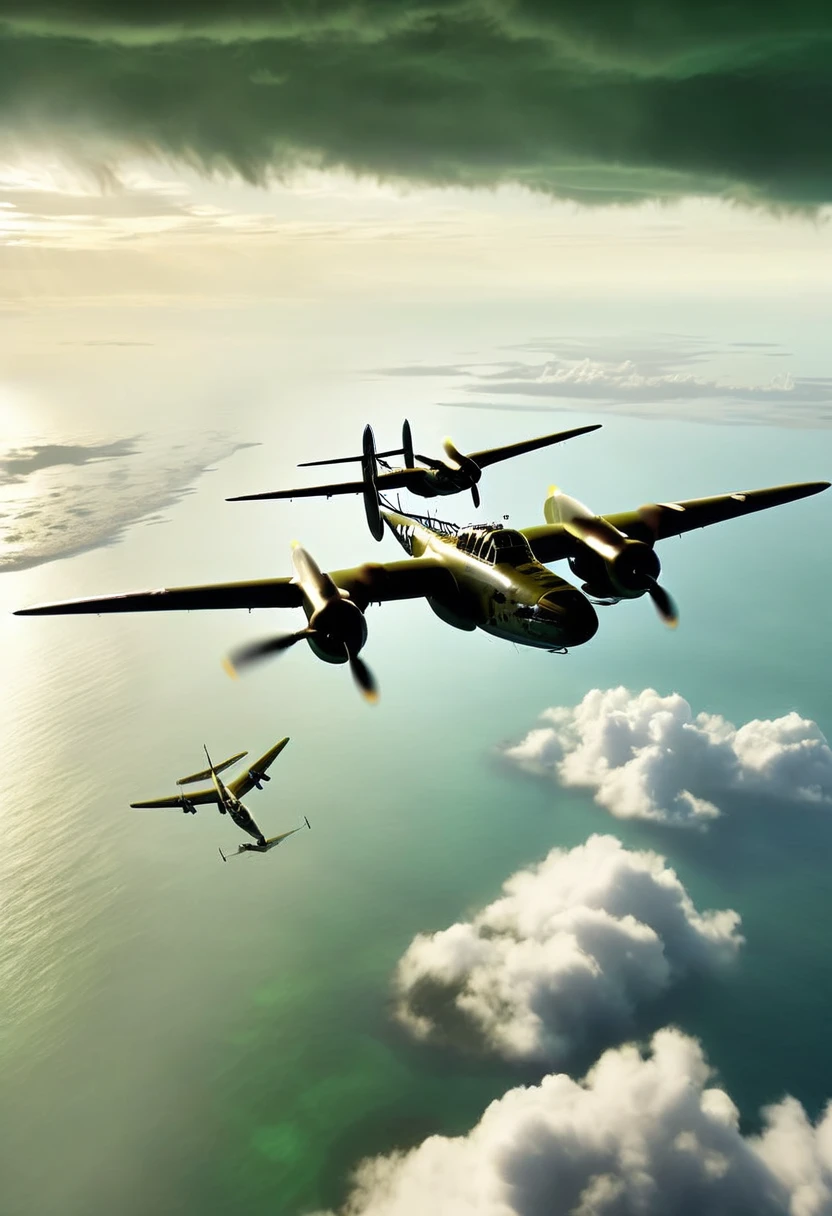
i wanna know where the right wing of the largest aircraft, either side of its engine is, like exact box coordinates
[523,482,830,562]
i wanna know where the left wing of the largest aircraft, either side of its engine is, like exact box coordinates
[15,557,451,617]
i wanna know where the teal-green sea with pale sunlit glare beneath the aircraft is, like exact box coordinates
[0,296,832,1216]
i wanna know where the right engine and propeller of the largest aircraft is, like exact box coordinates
[544,485,679,629]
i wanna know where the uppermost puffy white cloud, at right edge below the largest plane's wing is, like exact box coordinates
[504,688,832,827]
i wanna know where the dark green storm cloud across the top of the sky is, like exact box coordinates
[0,0,832,206]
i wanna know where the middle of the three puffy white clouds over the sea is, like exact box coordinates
[394,835,742,1064]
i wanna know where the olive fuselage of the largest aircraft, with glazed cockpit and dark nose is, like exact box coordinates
[383,512,598,651]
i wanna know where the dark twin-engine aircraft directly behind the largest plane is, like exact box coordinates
[226,418,601,540]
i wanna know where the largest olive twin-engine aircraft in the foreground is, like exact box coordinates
[17,482,830,700]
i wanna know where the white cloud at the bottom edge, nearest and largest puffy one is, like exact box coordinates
[323,1029,832,1216]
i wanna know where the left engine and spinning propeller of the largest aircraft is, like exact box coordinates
[223,544,378,702]
